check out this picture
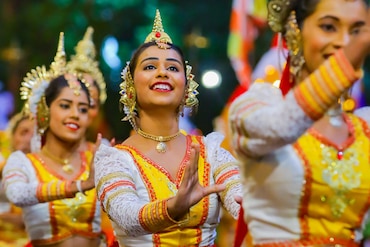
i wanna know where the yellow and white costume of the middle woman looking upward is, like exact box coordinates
[95,133,241,247]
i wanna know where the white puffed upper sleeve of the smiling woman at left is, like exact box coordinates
[3,151,39,207]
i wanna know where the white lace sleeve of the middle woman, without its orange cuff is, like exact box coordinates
[94,145,148,236]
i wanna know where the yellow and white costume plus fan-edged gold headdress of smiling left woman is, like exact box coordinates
[2,33,102,245]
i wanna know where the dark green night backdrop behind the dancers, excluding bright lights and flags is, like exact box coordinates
[0,0,370,140]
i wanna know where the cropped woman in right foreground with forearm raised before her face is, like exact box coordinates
[229,0,370,246]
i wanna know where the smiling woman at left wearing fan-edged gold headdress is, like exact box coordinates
[3,33,101,247]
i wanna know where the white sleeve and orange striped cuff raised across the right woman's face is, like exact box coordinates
[229,50,358,159]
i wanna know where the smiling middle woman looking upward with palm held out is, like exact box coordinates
[94,8,241,247]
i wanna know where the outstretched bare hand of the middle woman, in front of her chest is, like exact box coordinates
[167,144,225,220]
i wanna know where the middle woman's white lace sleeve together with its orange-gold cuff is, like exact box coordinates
[94,145,178,236]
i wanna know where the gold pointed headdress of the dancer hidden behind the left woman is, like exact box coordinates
[67,27,107,104]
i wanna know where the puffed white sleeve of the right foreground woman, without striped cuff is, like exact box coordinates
[229,83,313,157]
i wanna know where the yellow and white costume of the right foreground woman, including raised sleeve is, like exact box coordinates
[229,51,370,247]
